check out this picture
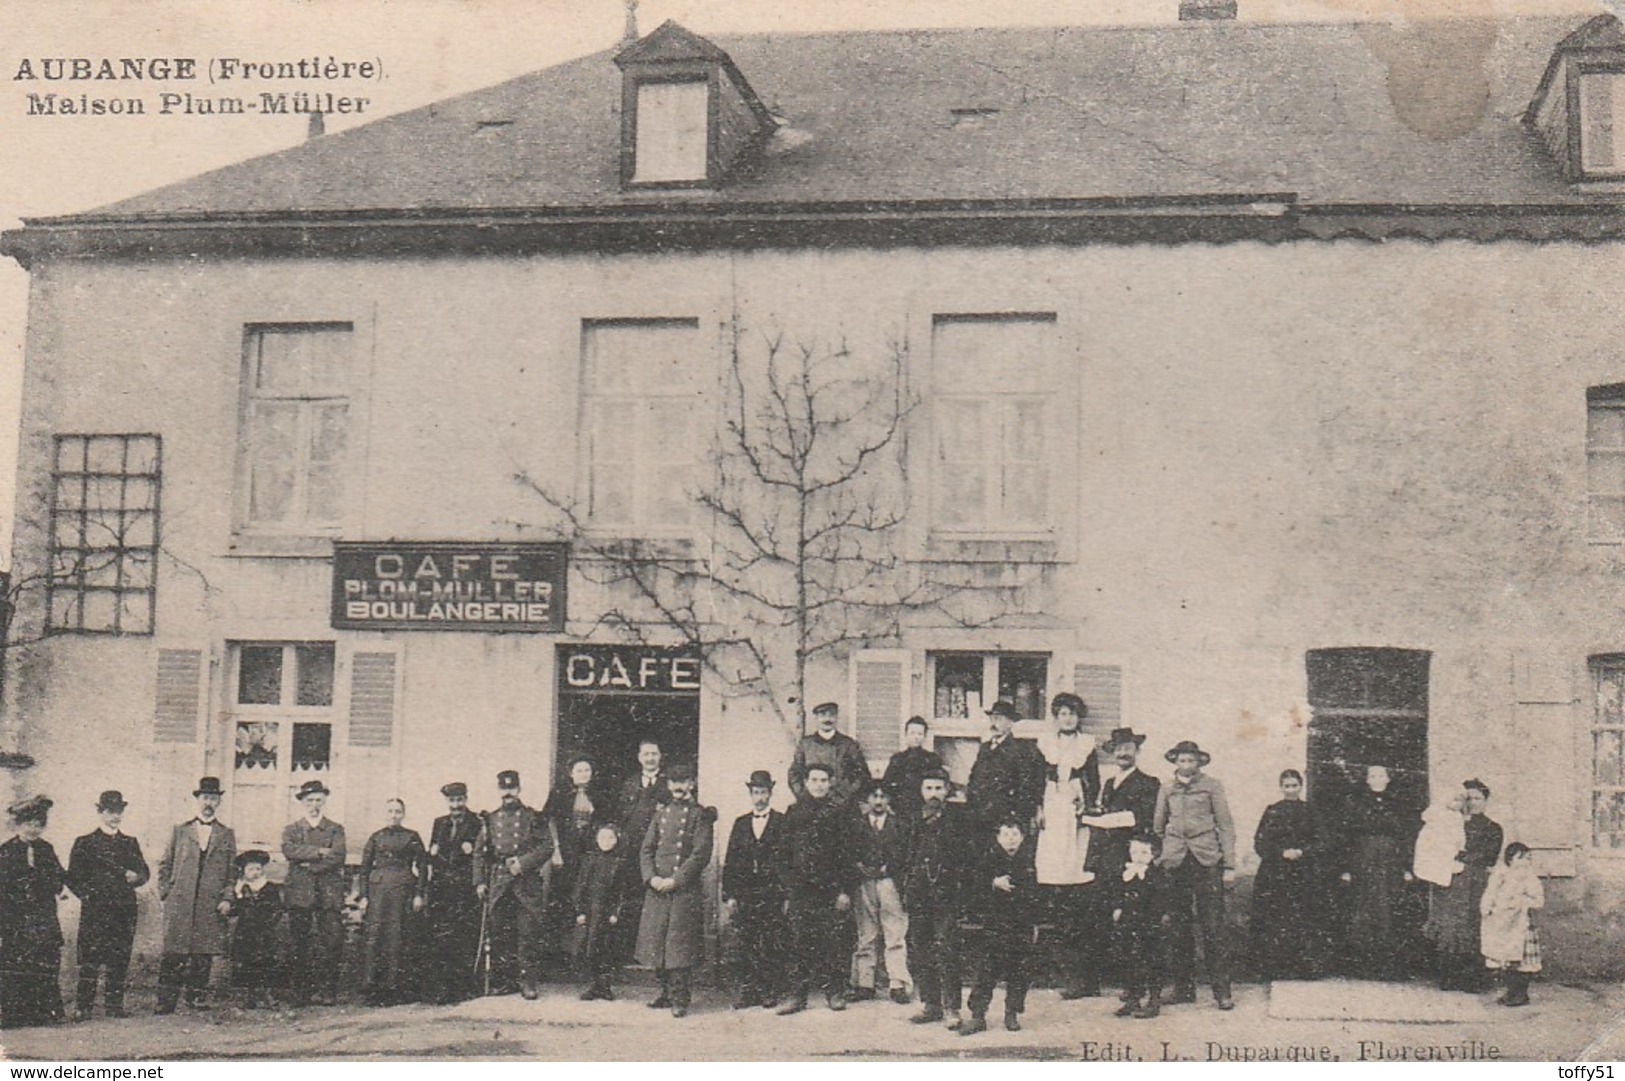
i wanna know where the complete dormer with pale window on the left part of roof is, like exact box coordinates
[614,21,775,189]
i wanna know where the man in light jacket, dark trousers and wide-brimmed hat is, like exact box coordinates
[1154,740,1235,1009]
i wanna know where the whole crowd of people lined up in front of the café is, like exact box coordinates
[0,694,1542,1035]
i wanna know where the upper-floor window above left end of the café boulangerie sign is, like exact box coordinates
[242,323,354,533]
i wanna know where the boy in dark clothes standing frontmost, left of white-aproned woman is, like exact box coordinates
[959,818,1038,1035]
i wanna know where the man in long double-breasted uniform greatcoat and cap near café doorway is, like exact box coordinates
[637,762,717,1018]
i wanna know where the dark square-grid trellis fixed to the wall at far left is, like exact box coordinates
[46,436,161,634]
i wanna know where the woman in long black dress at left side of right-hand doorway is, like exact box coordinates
[1248,769,1326,980]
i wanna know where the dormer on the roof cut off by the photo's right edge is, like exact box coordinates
[1524,15,1625,182]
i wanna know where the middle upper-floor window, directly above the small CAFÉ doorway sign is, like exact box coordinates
[583,319,709,532]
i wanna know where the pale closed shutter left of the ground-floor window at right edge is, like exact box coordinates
[1514,653,1591,878]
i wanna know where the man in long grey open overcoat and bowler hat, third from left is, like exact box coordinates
[158,777,237,1013]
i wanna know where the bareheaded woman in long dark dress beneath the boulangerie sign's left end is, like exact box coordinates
[361,800,429,1006]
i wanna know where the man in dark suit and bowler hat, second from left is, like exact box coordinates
[68,790,151,1021]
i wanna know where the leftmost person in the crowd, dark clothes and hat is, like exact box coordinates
[0,797,67,1029]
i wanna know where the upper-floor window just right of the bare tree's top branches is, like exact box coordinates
[931,314,1056,533]
